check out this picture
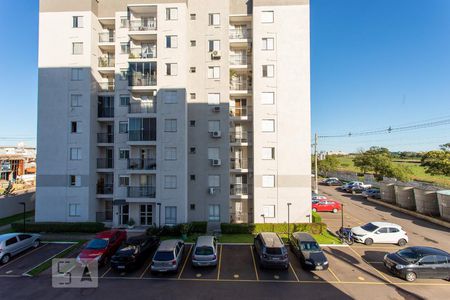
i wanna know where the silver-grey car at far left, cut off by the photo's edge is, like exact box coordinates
[0,233,41,264]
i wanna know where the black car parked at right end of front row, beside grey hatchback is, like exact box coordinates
[289,232,328,270]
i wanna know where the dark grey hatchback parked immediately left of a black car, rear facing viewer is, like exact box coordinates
[254,232,289,270]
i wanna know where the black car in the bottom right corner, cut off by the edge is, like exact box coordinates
[384,247,450,281]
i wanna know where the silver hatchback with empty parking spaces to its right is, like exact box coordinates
[192,236,217,267]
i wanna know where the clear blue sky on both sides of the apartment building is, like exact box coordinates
[0,0,450,152]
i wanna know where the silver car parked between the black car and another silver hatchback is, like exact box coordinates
[150,240,184,273]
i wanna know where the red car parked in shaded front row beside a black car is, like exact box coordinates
[77,230,127,265]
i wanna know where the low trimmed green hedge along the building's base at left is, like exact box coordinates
[11,222,105,233]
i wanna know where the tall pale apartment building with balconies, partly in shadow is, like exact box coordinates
[36,0,311,226]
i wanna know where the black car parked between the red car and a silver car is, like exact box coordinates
[111,235,159,271]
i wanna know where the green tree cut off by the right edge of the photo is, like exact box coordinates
[421,143,450,176]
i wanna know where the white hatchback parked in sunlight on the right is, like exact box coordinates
[351,222,408,247]
